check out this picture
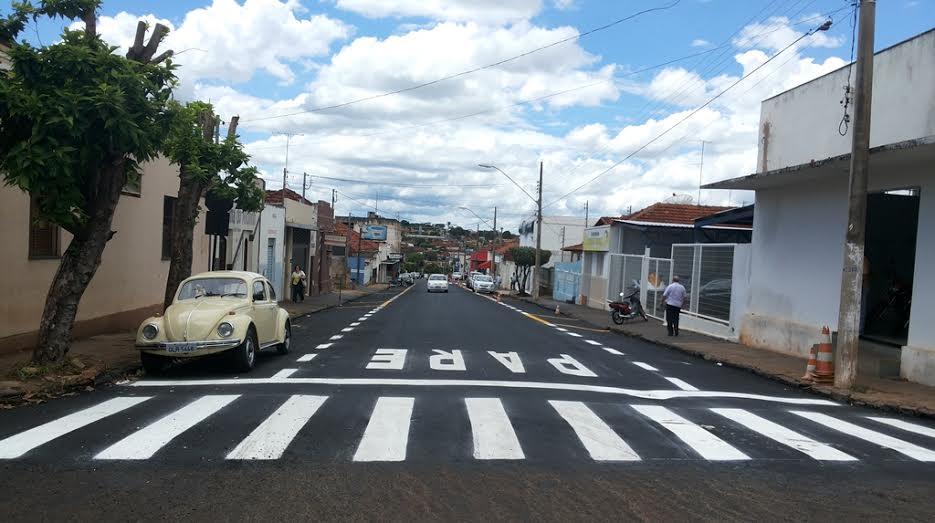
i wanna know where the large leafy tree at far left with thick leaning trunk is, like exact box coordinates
[0,0,176,364]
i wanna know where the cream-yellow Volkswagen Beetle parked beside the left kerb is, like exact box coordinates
[136,271,292,373]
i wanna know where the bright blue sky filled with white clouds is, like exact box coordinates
[7,0,935,231]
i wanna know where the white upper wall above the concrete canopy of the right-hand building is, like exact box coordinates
[757,30,935,173]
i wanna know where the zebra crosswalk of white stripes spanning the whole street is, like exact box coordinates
[0,394,935,463]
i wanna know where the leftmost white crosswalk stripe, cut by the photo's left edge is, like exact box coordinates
[0,396,152,459]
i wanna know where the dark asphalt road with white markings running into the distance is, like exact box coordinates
[0,281,935,521]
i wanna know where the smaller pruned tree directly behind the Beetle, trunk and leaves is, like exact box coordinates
[163,102,263,308]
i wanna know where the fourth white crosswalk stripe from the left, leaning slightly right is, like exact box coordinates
[354,397,416,461]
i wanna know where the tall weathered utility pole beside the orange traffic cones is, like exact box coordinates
[834,0,877,389]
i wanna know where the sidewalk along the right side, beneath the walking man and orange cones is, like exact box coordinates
[510,290,935,417]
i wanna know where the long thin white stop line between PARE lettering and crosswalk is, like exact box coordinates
[123,380,840,407]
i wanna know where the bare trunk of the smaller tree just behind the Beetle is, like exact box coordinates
[163,174,204,310]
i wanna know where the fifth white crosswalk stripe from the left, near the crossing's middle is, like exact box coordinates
[464,398,526,459]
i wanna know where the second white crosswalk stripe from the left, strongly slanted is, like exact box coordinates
[94,394,240,459]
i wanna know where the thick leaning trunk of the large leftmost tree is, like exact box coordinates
[32,162,127,365]
